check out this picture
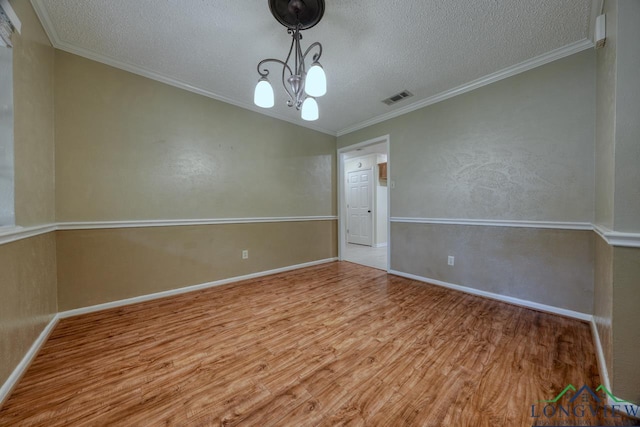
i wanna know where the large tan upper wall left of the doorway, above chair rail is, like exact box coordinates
[55,51,336,221]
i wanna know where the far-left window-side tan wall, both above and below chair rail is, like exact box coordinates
[0,0,57,396]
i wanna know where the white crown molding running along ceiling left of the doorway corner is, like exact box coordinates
[26,0,336,136]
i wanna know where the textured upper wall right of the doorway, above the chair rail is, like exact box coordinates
[338,51,595,222]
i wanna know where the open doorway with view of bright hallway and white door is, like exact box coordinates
[338,135,391,271]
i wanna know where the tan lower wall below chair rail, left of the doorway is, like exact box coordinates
[57,221,337,310]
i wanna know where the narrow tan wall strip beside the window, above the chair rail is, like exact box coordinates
[10,0,55,226]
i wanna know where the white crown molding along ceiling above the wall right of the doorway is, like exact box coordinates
[337,39,593,136]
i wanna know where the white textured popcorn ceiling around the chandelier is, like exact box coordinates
[32,0,596,135]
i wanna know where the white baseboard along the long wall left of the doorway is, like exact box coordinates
[58,258,338,319]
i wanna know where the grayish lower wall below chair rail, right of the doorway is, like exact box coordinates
[391,222,594,314]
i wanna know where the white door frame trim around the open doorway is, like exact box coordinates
[337,135,393,272]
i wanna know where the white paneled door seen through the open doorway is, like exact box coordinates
[347,169,373,246]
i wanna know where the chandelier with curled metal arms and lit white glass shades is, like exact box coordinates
[253,0,327,121]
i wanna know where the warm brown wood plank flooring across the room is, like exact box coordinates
[0,262,637,426]
